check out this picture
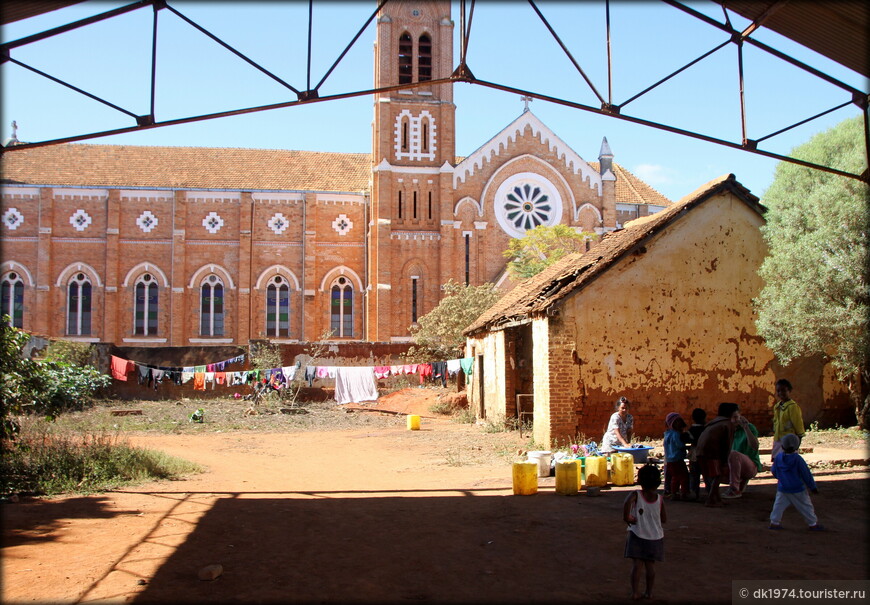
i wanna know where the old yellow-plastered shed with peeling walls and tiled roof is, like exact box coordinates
[465,175,851,444]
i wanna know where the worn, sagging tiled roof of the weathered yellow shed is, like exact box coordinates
[463,174,763,336]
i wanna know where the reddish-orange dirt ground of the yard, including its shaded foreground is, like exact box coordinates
[2,396,870,603]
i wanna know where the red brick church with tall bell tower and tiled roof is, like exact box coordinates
[0,1,670,346]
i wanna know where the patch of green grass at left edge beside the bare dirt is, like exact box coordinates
[0,421,202,496]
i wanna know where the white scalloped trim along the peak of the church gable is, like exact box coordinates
[453,111,601,195]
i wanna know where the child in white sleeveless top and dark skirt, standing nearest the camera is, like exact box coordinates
[622,464,667,600]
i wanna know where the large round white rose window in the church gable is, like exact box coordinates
[495,172,562,237]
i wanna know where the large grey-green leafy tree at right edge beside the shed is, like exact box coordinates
[755,117,870,429]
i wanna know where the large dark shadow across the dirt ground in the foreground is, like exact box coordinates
[135,478,868,603]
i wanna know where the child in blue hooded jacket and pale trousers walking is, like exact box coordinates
[770,433,825,531]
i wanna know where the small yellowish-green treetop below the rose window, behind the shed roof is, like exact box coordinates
[502,223,598,279]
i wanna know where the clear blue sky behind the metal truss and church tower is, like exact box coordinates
[0,0,868,200]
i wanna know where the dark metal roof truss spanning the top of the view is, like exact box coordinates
[0,0,870,183]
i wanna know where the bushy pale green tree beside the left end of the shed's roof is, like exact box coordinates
[406,280,501,361]
